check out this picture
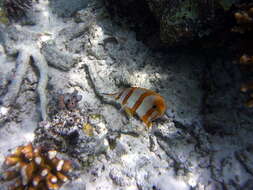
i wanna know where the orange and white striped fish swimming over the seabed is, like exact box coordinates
[104,87,167,127]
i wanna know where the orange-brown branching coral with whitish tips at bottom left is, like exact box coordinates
[1,143,72,190]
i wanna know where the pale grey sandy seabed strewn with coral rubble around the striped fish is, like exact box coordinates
[0,0,253,190]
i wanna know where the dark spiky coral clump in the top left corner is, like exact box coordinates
[3,0,32,21]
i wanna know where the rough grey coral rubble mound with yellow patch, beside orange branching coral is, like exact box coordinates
[35,91,107,162]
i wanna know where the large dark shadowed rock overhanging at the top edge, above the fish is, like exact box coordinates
[106,0,243,46]
